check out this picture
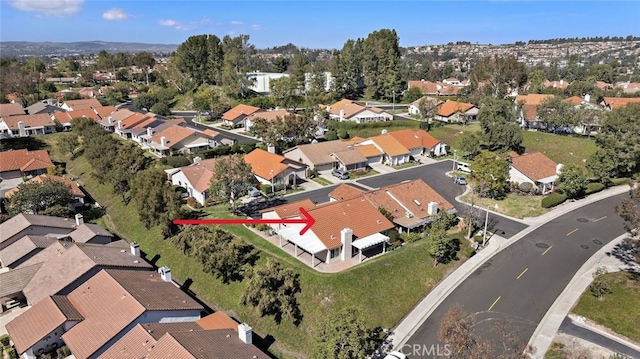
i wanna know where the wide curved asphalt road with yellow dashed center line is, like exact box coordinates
[408,194,627,358]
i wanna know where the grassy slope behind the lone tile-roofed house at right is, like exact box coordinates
[522,131,596,165]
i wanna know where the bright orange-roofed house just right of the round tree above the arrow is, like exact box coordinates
[244,148,307,187]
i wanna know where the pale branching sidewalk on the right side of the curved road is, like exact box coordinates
[529,234,640,358]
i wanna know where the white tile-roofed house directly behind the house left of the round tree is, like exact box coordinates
[148,124,214,156]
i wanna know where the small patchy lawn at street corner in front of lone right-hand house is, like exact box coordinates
[462,193,549,219]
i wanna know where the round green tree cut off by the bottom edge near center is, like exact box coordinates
[313,307,376,359]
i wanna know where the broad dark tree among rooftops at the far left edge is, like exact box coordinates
[7,179,74,215]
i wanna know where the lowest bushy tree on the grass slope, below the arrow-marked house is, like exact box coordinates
[240,258,302,325]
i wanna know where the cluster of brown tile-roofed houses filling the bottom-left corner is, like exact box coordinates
[0,214,268,359]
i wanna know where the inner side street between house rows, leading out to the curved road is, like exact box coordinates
[357,160,527,238]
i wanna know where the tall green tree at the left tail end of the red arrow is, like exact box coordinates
[131,168,181,237]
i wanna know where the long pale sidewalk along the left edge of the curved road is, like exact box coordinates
[387,185,629,355]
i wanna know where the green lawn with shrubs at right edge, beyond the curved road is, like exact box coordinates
[573,272,640,343]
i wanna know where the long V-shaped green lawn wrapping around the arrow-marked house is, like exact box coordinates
[62,150,466,358]
